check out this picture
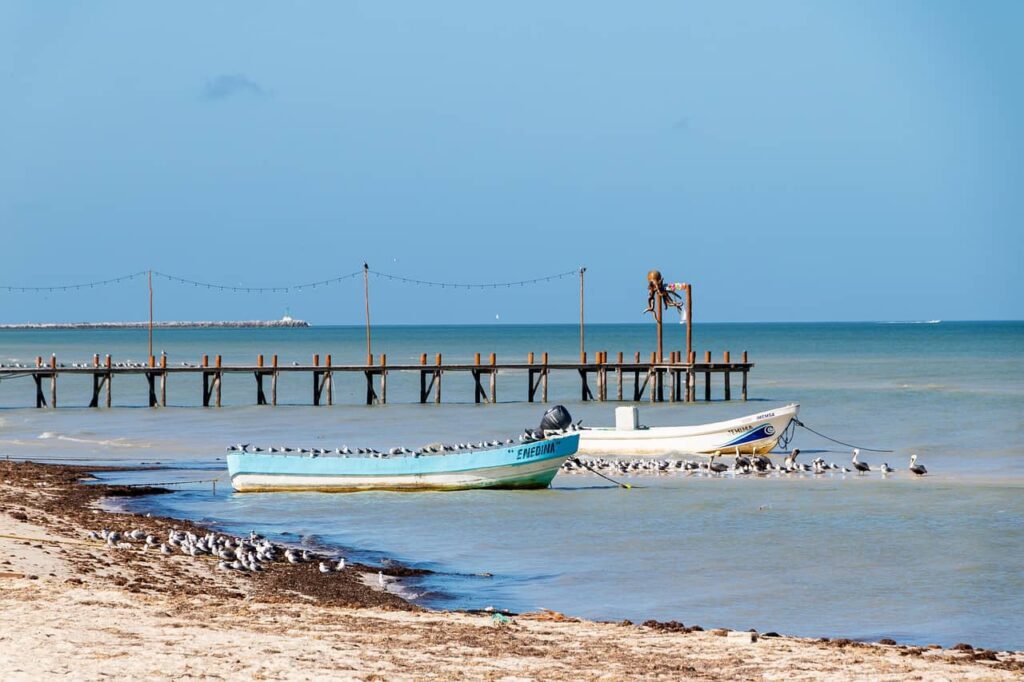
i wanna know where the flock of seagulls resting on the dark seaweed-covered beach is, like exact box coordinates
[82,528,395,588]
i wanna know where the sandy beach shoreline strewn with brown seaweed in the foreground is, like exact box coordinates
[0,462,1024,679]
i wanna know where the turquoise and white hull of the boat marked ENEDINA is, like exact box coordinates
[227,433,580,493]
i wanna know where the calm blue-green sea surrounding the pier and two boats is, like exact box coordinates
[0,322,1024,649]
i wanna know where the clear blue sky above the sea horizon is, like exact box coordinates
[0,0,1024,324]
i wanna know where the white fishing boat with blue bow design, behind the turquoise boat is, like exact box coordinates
[579,403,800,457]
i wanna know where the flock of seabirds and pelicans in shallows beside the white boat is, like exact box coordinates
[561,450,928,476]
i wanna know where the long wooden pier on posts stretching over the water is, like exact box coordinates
[0,350,754,408]
